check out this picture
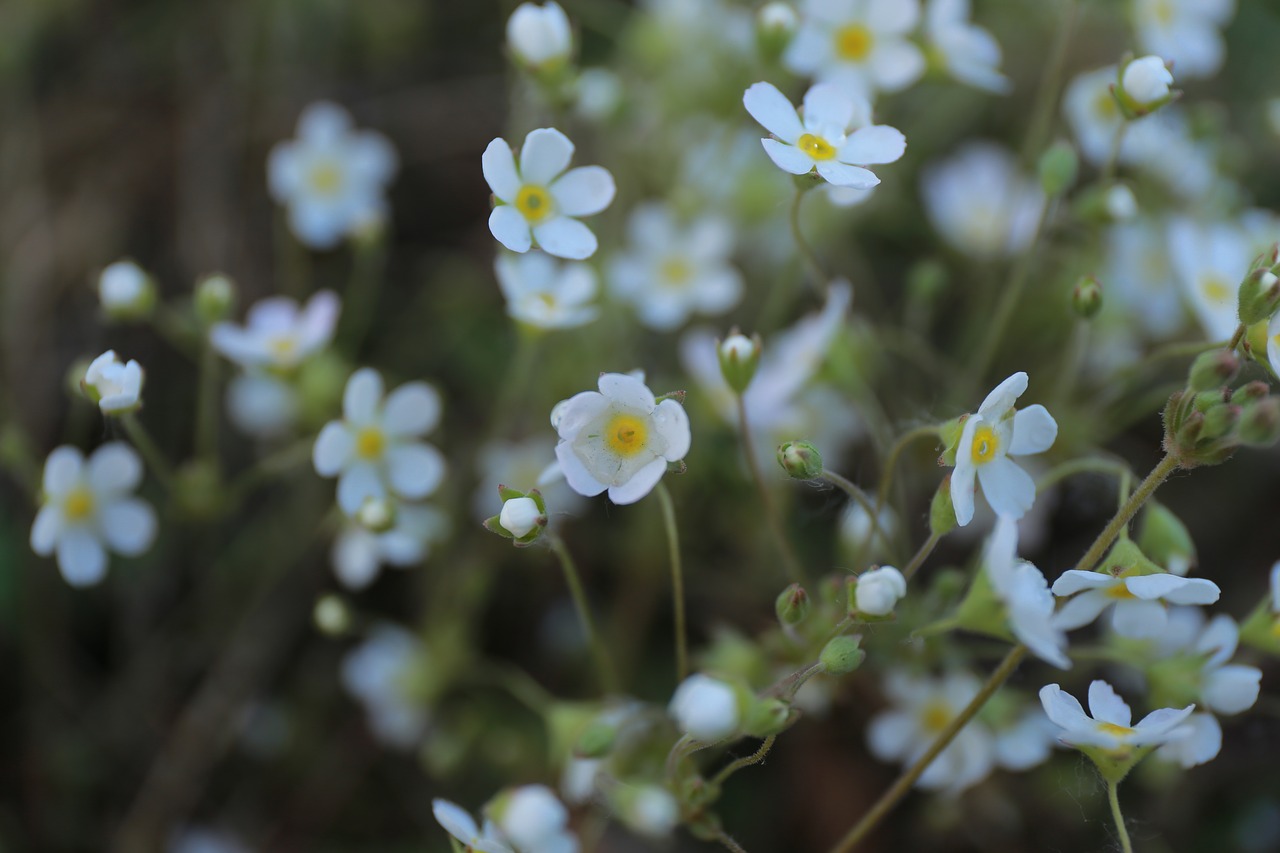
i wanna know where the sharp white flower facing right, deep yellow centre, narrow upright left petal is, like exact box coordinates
[951,373,1057,526]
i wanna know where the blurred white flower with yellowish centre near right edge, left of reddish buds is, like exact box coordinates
[1169,218,1253,341]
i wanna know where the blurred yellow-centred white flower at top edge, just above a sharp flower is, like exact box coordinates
[782,0,925,99]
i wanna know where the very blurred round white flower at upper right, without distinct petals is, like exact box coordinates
[920,142,1044,259]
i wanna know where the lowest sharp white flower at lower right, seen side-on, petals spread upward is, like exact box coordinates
[1039,680,1196,752]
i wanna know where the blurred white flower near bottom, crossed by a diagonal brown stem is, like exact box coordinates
[867,672,995,792]
